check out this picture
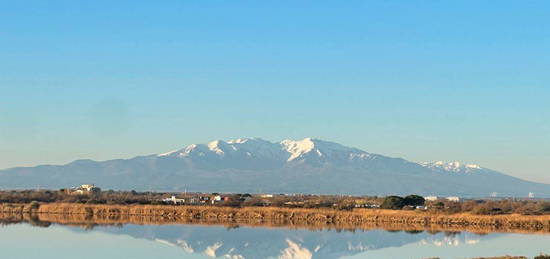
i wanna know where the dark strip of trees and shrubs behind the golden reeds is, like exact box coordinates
[0,190,550,215]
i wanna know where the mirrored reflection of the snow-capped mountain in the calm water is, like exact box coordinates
[94,225,488,259]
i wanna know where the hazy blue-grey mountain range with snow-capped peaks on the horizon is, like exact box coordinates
[0,138,550,197]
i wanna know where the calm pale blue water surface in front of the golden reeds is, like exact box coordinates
[0,223,550,259]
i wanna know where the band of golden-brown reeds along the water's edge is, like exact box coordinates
[0,203,550,234]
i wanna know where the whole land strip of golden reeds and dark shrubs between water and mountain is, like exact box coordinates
[0,190,550,233]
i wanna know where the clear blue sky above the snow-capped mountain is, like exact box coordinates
[0,0,550,183]
